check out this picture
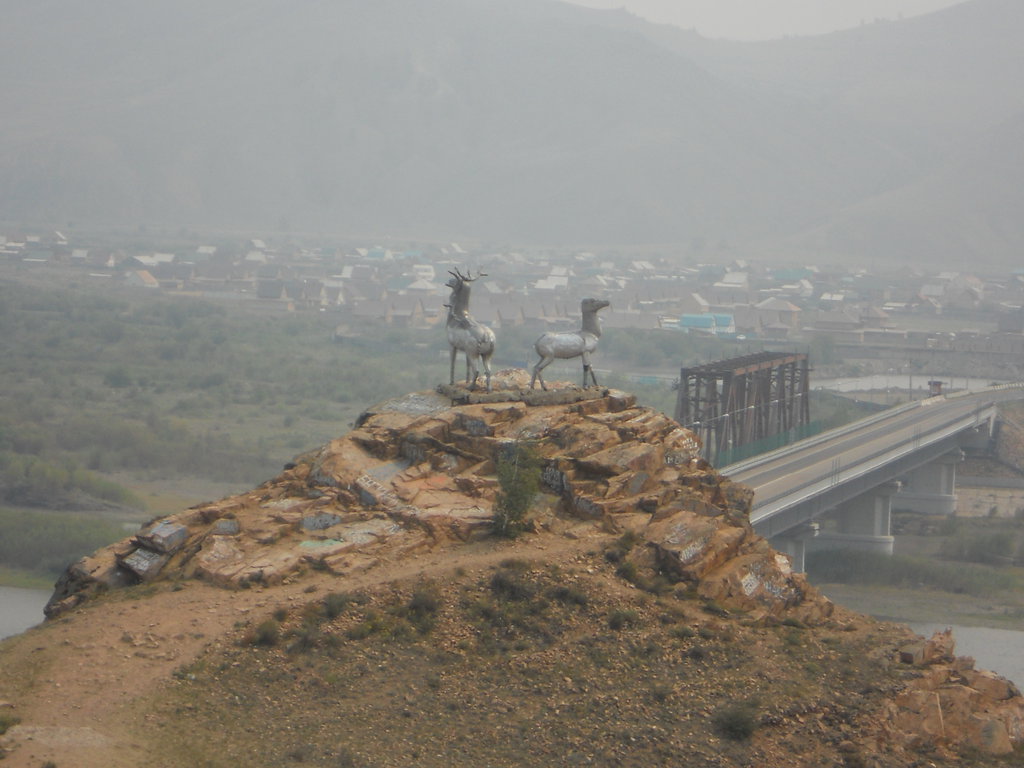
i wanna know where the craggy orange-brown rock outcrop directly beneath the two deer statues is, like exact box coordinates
[47,371,830,618]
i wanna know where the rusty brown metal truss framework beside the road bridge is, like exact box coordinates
[676,352,810,464]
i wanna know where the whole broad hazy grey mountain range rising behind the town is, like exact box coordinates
[0,0,1024,266]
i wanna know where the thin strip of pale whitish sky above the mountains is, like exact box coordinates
[568,0,964,40]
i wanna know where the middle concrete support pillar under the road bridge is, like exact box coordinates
[807,482,900,555]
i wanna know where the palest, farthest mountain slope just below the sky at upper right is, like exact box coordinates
[640,0,1024,158]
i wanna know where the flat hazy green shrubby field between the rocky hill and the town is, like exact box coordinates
[0,279,858,574]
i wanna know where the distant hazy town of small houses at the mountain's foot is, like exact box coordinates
[0,231,1024,384]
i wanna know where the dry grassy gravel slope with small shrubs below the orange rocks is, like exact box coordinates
[153,553,921,767]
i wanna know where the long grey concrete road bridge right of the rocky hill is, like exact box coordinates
[719,382,1024,570]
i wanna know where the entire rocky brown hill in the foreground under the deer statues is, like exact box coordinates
[0,371,1024,766]
